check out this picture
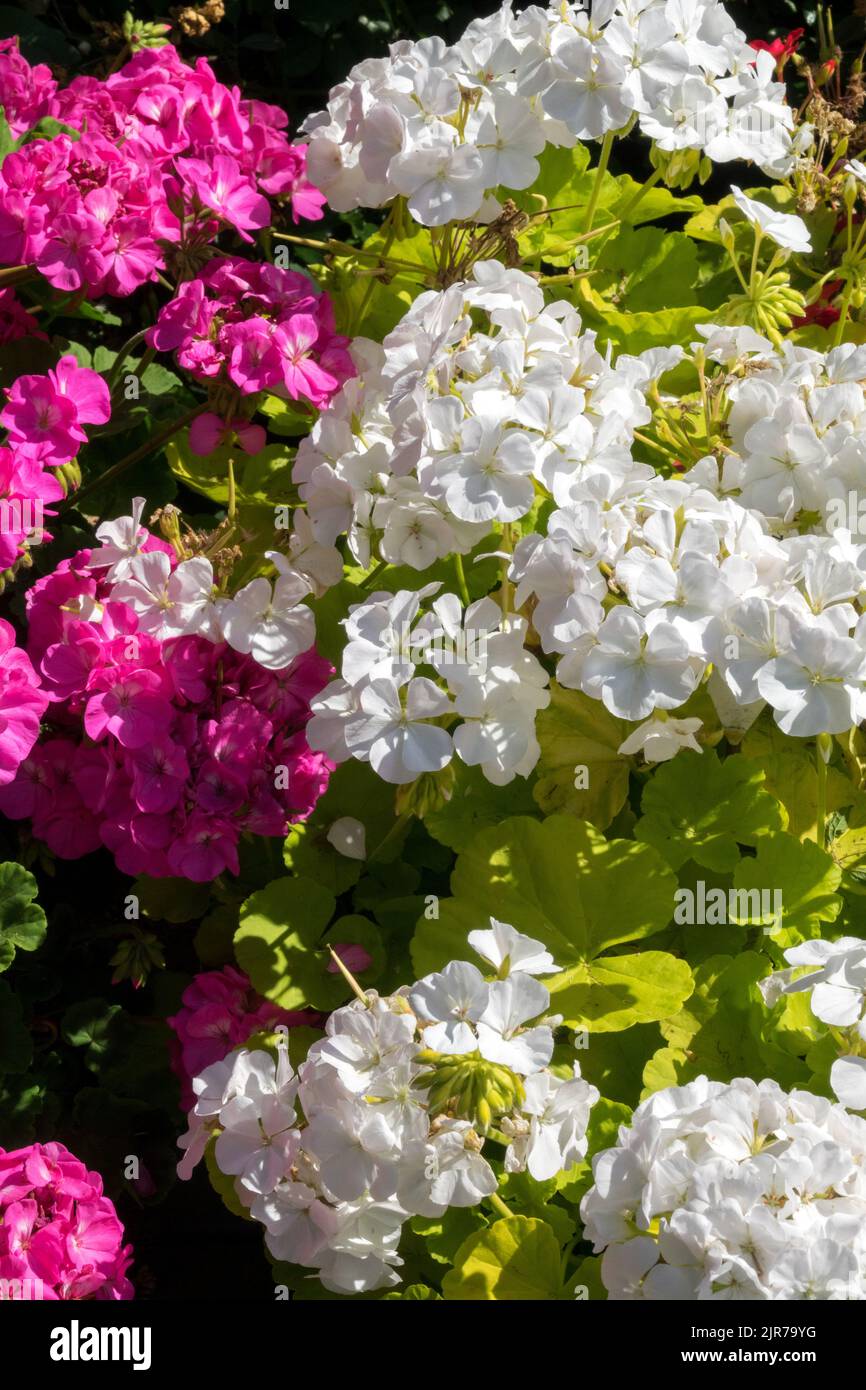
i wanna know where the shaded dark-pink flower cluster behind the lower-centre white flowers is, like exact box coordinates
[167,965,324,1111]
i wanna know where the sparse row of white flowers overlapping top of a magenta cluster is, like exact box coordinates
[88,498,316,671]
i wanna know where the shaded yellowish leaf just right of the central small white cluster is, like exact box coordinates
[536,681,632,833]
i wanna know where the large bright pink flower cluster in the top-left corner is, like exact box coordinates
[0,40,324,297]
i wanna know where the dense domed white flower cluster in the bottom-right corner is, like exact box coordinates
[581,1076,866,1301]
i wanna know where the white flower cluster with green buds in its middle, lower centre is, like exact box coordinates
[178,920,598,1293]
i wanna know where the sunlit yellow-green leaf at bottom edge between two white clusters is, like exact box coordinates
[442,1216,563,1302]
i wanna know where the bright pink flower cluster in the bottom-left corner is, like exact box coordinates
[0,1144,135,1301]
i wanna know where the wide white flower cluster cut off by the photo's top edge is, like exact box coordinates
[303,0,794,227]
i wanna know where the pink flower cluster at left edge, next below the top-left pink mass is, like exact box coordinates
[0,355,111,570]
